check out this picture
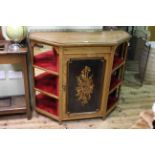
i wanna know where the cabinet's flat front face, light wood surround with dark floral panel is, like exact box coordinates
[61,47,113,120]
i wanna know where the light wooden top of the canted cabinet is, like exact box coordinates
[29,31,130,46]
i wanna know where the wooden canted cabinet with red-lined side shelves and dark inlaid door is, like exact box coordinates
[29,31,130,121]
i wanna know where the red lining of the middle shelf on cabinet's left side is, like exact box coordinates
[35,72,58,95]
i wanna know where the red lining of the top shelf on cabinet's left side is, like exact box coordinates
[34,49,59,72]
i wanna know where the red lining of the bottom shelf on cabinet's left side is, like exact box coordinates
[36,94,58,116]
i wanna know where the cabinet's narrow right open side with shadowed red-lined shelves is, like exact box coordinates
[106,43,127,114]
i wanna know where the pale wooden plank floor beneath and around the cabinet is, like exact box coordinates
[0,72,155,129]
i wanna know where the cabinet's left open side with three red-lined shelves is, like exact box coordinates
[33,47,59,120]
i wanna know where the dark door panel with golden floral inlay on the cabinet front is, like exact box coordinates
[66,58,106,114]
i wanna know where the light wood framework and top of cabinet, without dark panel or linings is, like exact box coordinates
[29,31,130,122]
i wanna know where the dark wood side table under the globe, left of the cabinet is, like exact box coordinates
[0,49,31,119]
